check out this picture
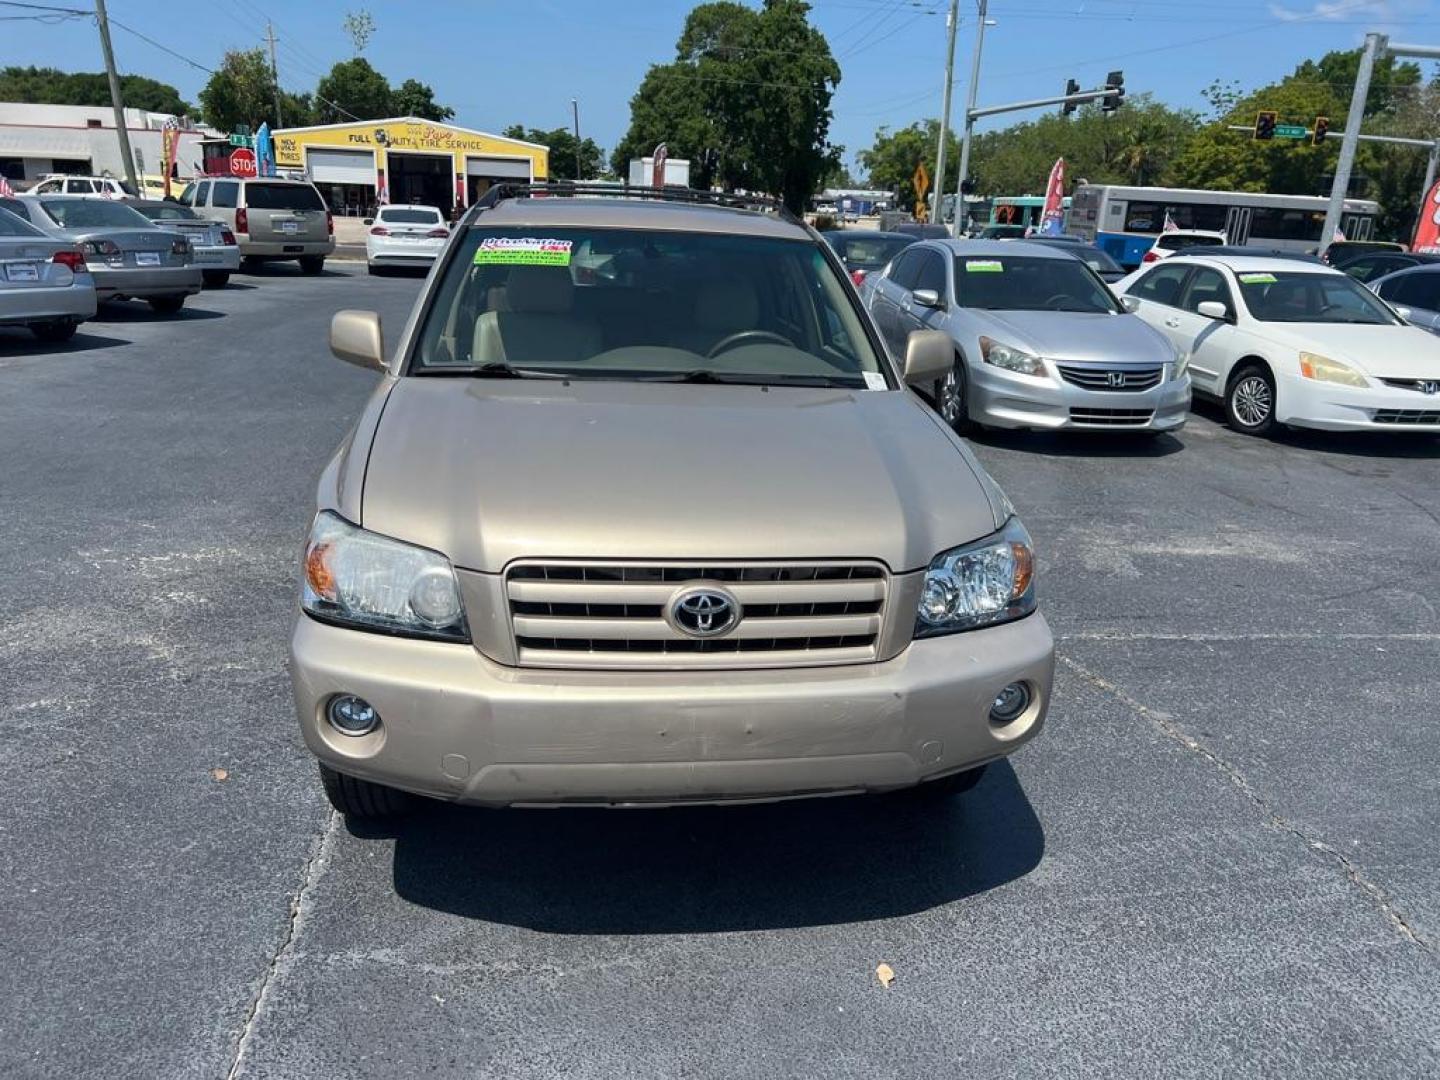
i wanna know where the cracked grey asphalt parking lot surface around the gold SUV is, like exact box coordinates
[0,265,1440,1080]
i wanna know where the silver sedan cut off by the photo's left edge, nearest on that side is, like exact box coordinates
[0,201,96,341]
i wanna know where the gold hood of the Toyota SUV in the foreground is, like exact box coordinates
[361,377,998,573]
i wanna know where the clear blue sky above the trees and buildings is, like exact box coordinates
[0,0,1440,173]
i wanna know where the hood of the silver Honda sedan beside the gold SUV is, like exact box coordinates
[966,308,1175,364]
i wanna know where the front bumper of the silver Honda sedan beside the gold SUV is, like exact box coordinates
[966,363,1189,431]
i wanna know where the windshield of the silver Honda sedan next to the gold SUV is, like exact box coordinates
[955,255,1120,314]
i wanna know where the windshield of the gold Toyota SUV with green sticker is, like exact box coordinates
[410,226,887,389]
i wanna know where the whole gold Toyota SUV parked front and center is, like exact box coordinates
[291,184,1054,816]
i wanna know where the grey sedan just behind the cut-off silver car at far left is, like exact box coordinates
[0,194,200,314]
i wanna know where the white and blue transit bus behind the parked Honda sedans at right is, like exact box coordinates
[1066,184,1380,268]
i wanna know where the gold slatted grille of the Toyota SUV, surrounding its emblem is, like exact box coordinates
[505,563,888,670]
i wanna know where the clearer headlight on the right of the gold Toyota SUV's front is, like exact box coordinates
[914,517,1035,638]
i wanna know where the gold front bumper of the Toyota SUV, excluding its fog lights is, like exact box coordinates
[291,613,1054,805]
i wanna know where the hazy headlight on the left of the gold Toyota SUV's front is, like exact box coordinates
[301,510,469,641]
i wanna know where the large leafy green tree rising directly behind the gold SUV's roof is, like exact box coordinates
[613,0,840,210]
